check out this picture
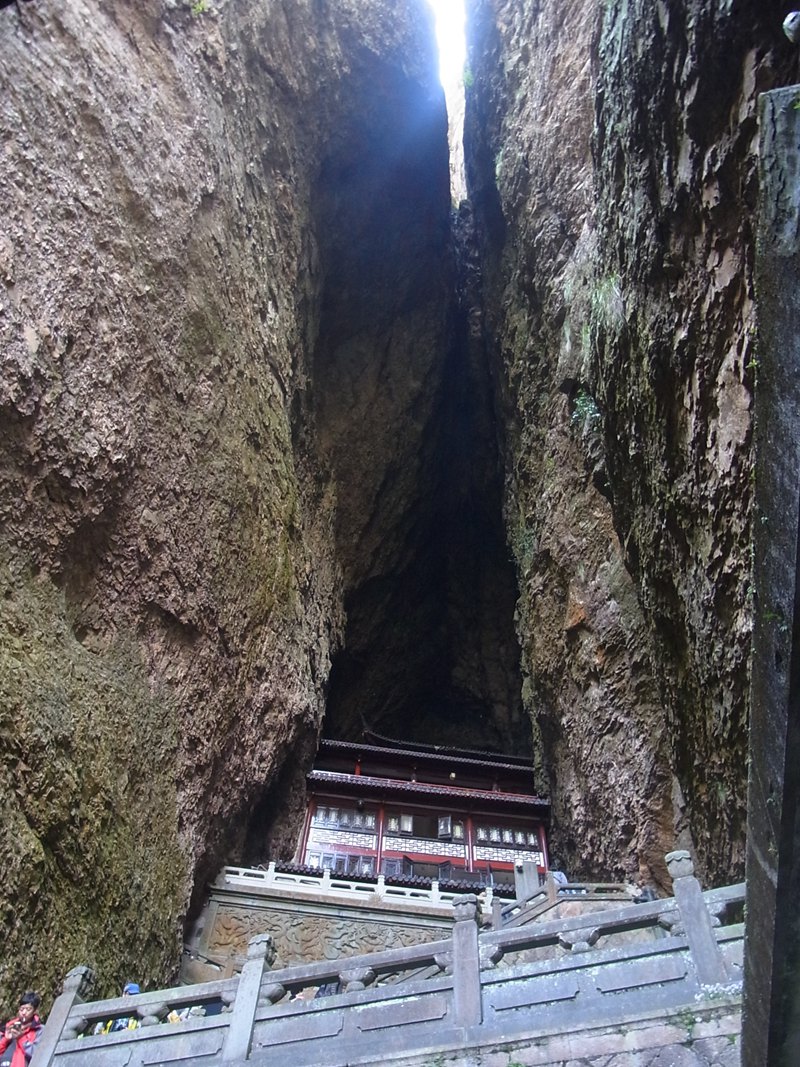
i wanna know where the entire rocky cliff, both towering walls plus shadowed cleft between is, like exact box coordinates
[0,0,794,996]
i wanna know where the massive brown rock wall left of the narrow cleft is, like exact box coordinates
[0,0,449,996]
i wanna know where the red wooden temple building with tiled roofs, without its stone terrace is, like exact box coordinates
[297,735,549,887]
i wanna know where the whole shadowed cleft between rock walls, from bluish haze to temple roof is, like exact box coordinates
[304,14,531,753]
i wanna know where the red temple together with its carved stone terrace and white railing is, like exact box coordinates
[181,734,549,982]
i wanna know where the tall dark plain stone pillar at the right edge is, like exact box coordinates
[742,85,800,1067]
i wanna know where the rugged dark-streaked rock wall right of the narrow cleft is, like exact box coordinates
[466,0,794,880]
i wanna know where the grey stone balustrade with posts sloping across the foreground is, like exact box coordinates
[32,854,743,1067]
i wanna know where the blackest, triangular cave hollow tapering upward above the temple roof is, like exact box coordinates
[324,316,532,754]
